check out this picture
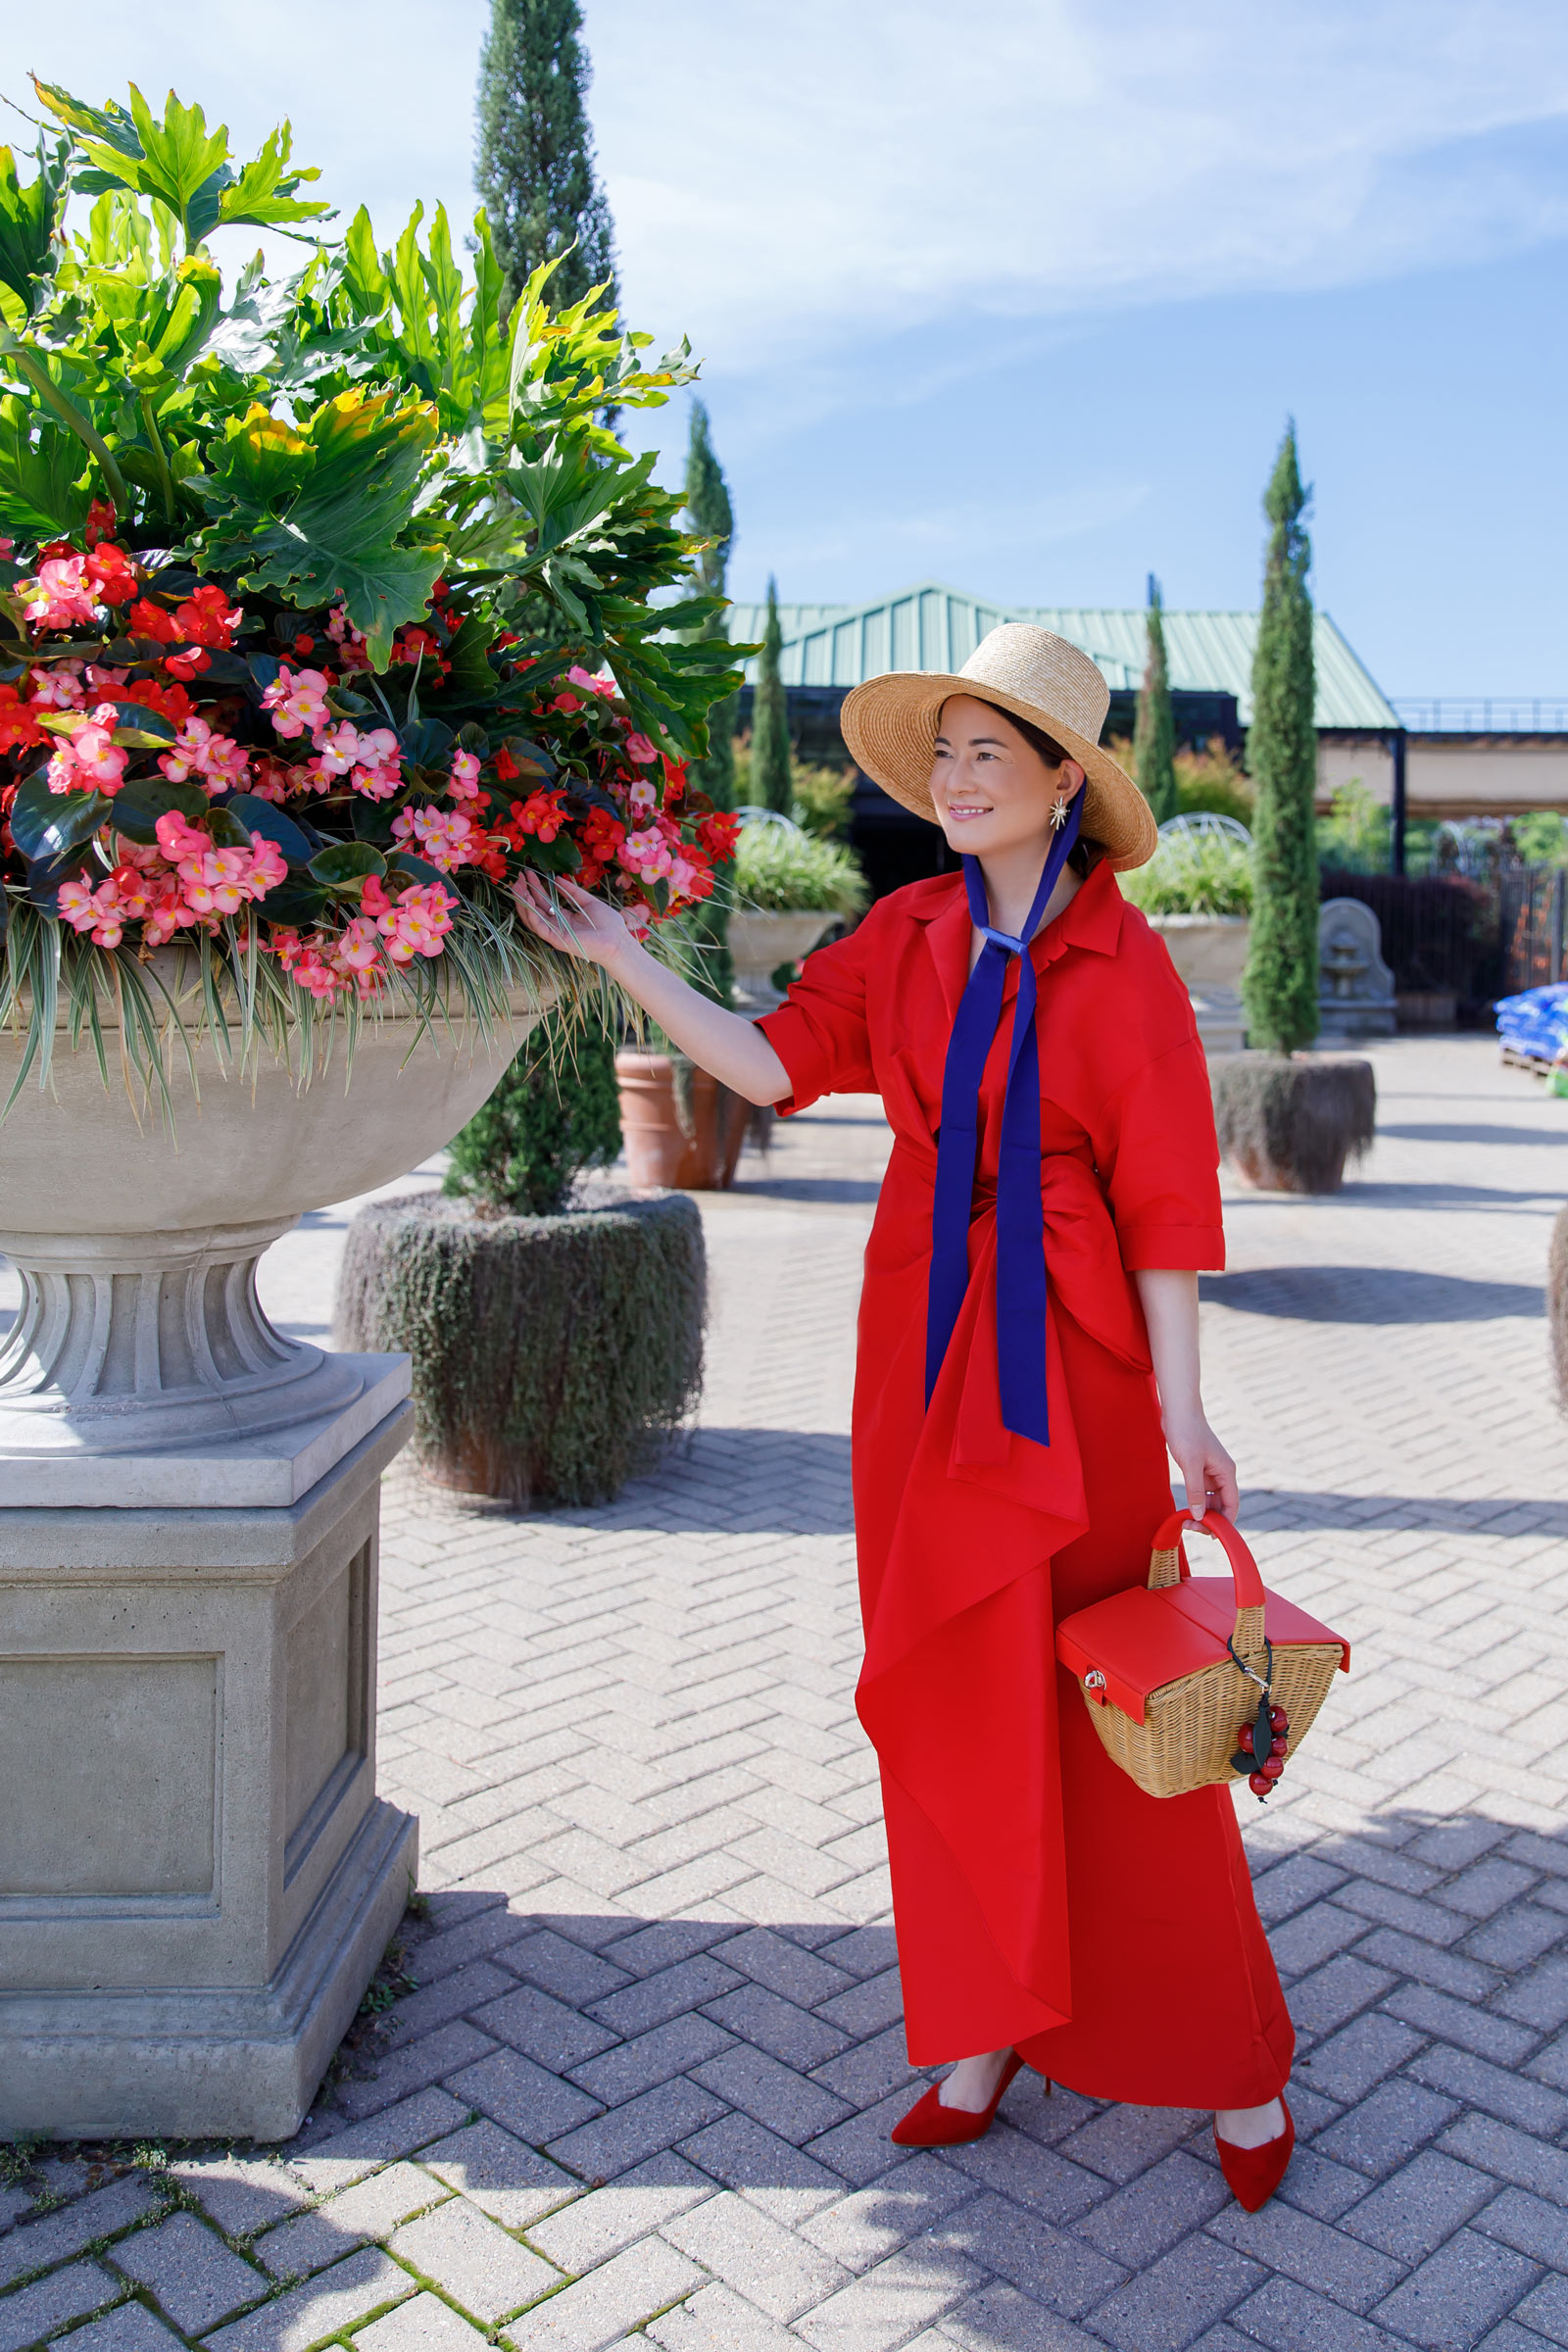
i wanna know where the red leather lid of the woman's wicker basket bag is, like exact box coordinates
[1055,1576,1349,1724]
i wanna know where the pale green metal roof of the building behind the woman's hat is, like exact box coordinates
[729,581,1398,731]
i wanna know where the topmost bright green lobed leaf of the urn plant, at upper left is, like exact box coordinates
[33,75,331,247]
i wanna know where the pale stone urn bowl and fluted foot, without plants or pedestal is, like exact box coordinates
[0,955,555,1467]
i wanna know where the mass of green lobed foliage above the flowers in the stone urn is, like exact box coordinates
[0,75,738,758]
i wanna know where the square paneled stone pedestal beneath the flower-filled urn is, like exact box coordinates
[0,1401,418,2140]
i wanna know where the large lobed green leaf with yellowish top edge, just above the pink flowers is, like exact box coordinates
[190,393,442,668]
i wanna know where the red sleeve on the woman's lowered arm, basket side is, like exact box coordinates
[1096,1037,1225,1275]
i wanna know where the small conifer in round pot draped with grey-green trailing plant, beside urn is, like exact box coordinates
[336,1013,706,1505]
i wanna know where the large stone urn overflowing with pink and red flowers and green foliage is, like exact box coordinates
[0,82,738,1456]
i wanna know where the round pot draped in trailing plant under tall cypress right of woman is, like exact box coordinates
[1213,1054,1378,1193]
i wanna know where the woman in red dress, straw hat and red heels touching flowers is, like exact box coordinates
[524,623,1293,2211]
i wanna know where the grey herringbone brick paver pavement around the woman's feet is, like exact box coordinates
[0,1040,1568,2352]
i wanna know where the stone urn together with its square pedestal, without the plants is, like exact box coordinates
[0,951,552,2140]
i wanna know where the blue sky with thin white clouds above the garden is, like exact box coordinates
[0,0,1568,694]
